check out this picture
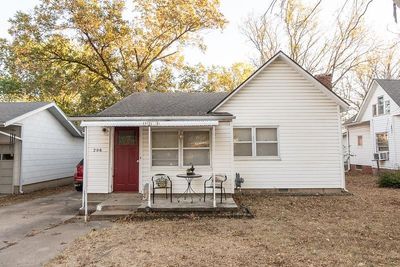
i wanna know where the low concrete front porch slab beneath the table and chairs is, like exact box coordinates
[90,193,247,220]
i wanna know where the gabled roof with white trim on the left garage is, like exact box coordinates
[0,102,82,137]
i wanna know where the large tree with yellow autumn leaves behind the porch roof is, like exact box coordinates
[5,0,226,113]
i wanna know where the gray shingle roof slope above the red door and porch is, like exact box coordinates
[96,92,230,117]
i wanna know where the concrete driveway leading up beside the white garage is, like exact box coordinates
[0,191,111,266]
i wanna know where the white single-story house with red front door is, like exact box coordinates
[79,52,348,197]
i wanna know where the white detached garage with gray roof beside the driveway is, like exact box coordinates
[0,102,83,194]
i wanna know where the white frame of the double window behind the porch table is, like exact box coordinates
[150,128,213,169]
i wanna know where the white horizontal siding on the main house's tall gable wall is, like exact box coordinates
[216,58,344,188]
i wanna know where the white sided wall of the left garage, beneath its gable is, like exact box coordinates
[21,110,83,184]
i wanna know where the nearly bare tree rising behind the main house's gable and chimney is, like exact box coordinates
[242,0,395,114]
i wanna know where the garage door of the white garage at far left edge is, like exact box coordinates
[0,145,14,194]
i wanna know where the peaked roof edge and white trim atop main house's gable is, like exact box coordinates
[209,51,349,112]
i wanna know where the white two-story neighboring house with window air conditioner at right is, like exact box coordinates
[345,79,400,173]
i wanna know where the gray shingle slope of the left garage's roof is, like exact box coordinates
[0,102,50,123]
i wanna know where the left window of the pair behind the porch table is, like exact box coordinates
[151,131,179,166]
